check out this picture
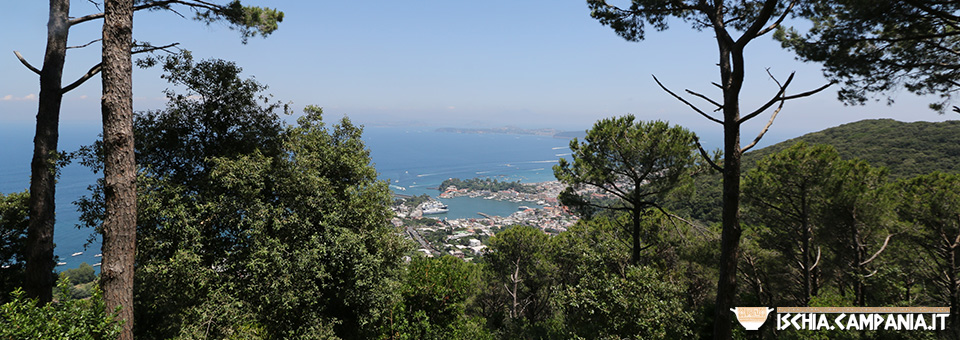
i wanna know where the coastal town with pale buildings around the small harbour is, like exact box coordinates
[392,181,578,261]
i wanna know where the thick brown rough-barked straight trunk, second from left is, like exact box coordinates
[101,0,137,340]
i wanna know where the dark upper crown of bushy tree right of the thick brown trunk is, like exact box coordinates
[134,52,286,190]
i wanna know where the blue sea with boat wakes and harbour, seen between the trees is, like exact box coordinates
[0,122,570,271]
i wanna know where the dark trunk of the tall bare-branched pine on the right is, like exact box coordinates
[713,39,743,339]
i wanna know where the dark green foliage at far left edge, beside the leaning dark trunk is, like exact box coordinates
[0,191,30,304]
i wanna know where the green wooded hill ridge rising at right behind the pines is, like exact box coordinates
[743,119,960,178]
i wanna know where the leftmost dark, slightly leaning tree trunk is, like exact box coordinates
[24,0,70,303]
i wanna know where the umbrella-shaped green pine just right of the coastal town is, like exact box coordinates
[553,115,699,263]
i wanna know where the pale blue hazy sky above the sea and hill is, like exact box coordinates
[0,0,956,148]
